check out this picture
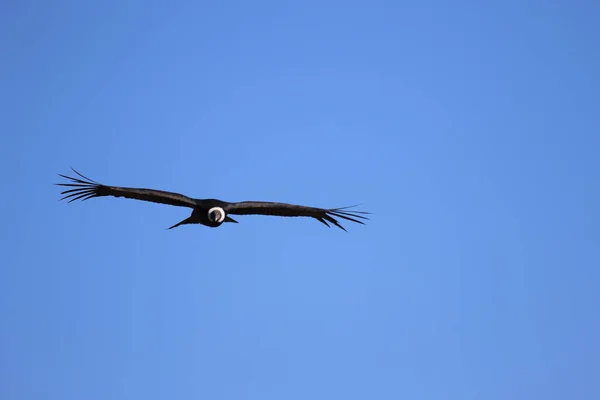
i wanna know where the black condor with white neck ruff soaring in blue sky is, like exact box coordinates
[56,168,369,231]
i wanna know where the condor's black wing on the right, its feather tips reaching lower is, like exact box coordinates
[225,201,369,230]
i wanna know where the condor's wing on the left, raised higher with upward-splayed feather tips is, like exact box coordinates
[56,168,196,208]
